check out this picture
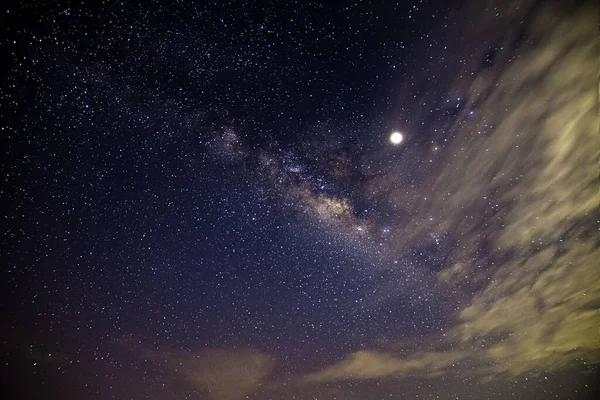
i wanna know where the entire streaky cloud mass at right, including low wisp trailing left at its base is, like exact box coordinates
[305,0,600,382]
